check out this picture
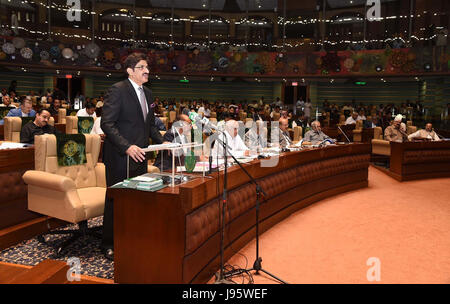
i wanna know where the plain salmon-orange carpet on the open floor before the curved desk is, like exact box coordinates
[215,167,450,284]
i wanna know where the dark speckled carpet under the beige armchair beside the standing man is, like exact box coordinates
[0,216,114,279]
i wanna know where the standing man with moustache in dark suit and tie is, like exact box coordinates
[101,53,163,259]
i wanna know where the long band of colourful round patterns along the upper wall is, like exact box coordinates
[0,37,450,77]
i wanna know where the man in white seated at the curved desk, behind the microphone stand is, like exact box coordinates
[212,119,250,158]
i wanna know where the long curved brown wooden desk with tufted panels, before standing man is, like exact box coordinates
[108,144,371,283]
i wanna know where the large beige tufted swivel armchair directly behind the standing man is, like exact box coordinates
[23,134,106,254]
